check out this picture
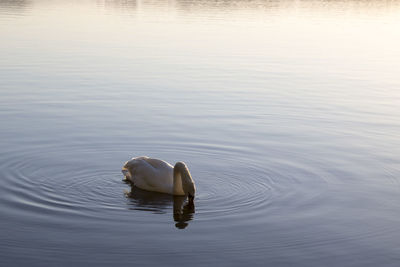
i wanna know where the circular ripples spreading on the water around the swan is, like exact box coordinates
[1,143,334,229]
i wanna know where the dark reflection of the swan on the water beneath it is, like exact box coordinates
[125,183,195,229]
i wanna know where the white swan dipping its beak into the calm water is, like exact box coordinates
[122,157,196,201]
